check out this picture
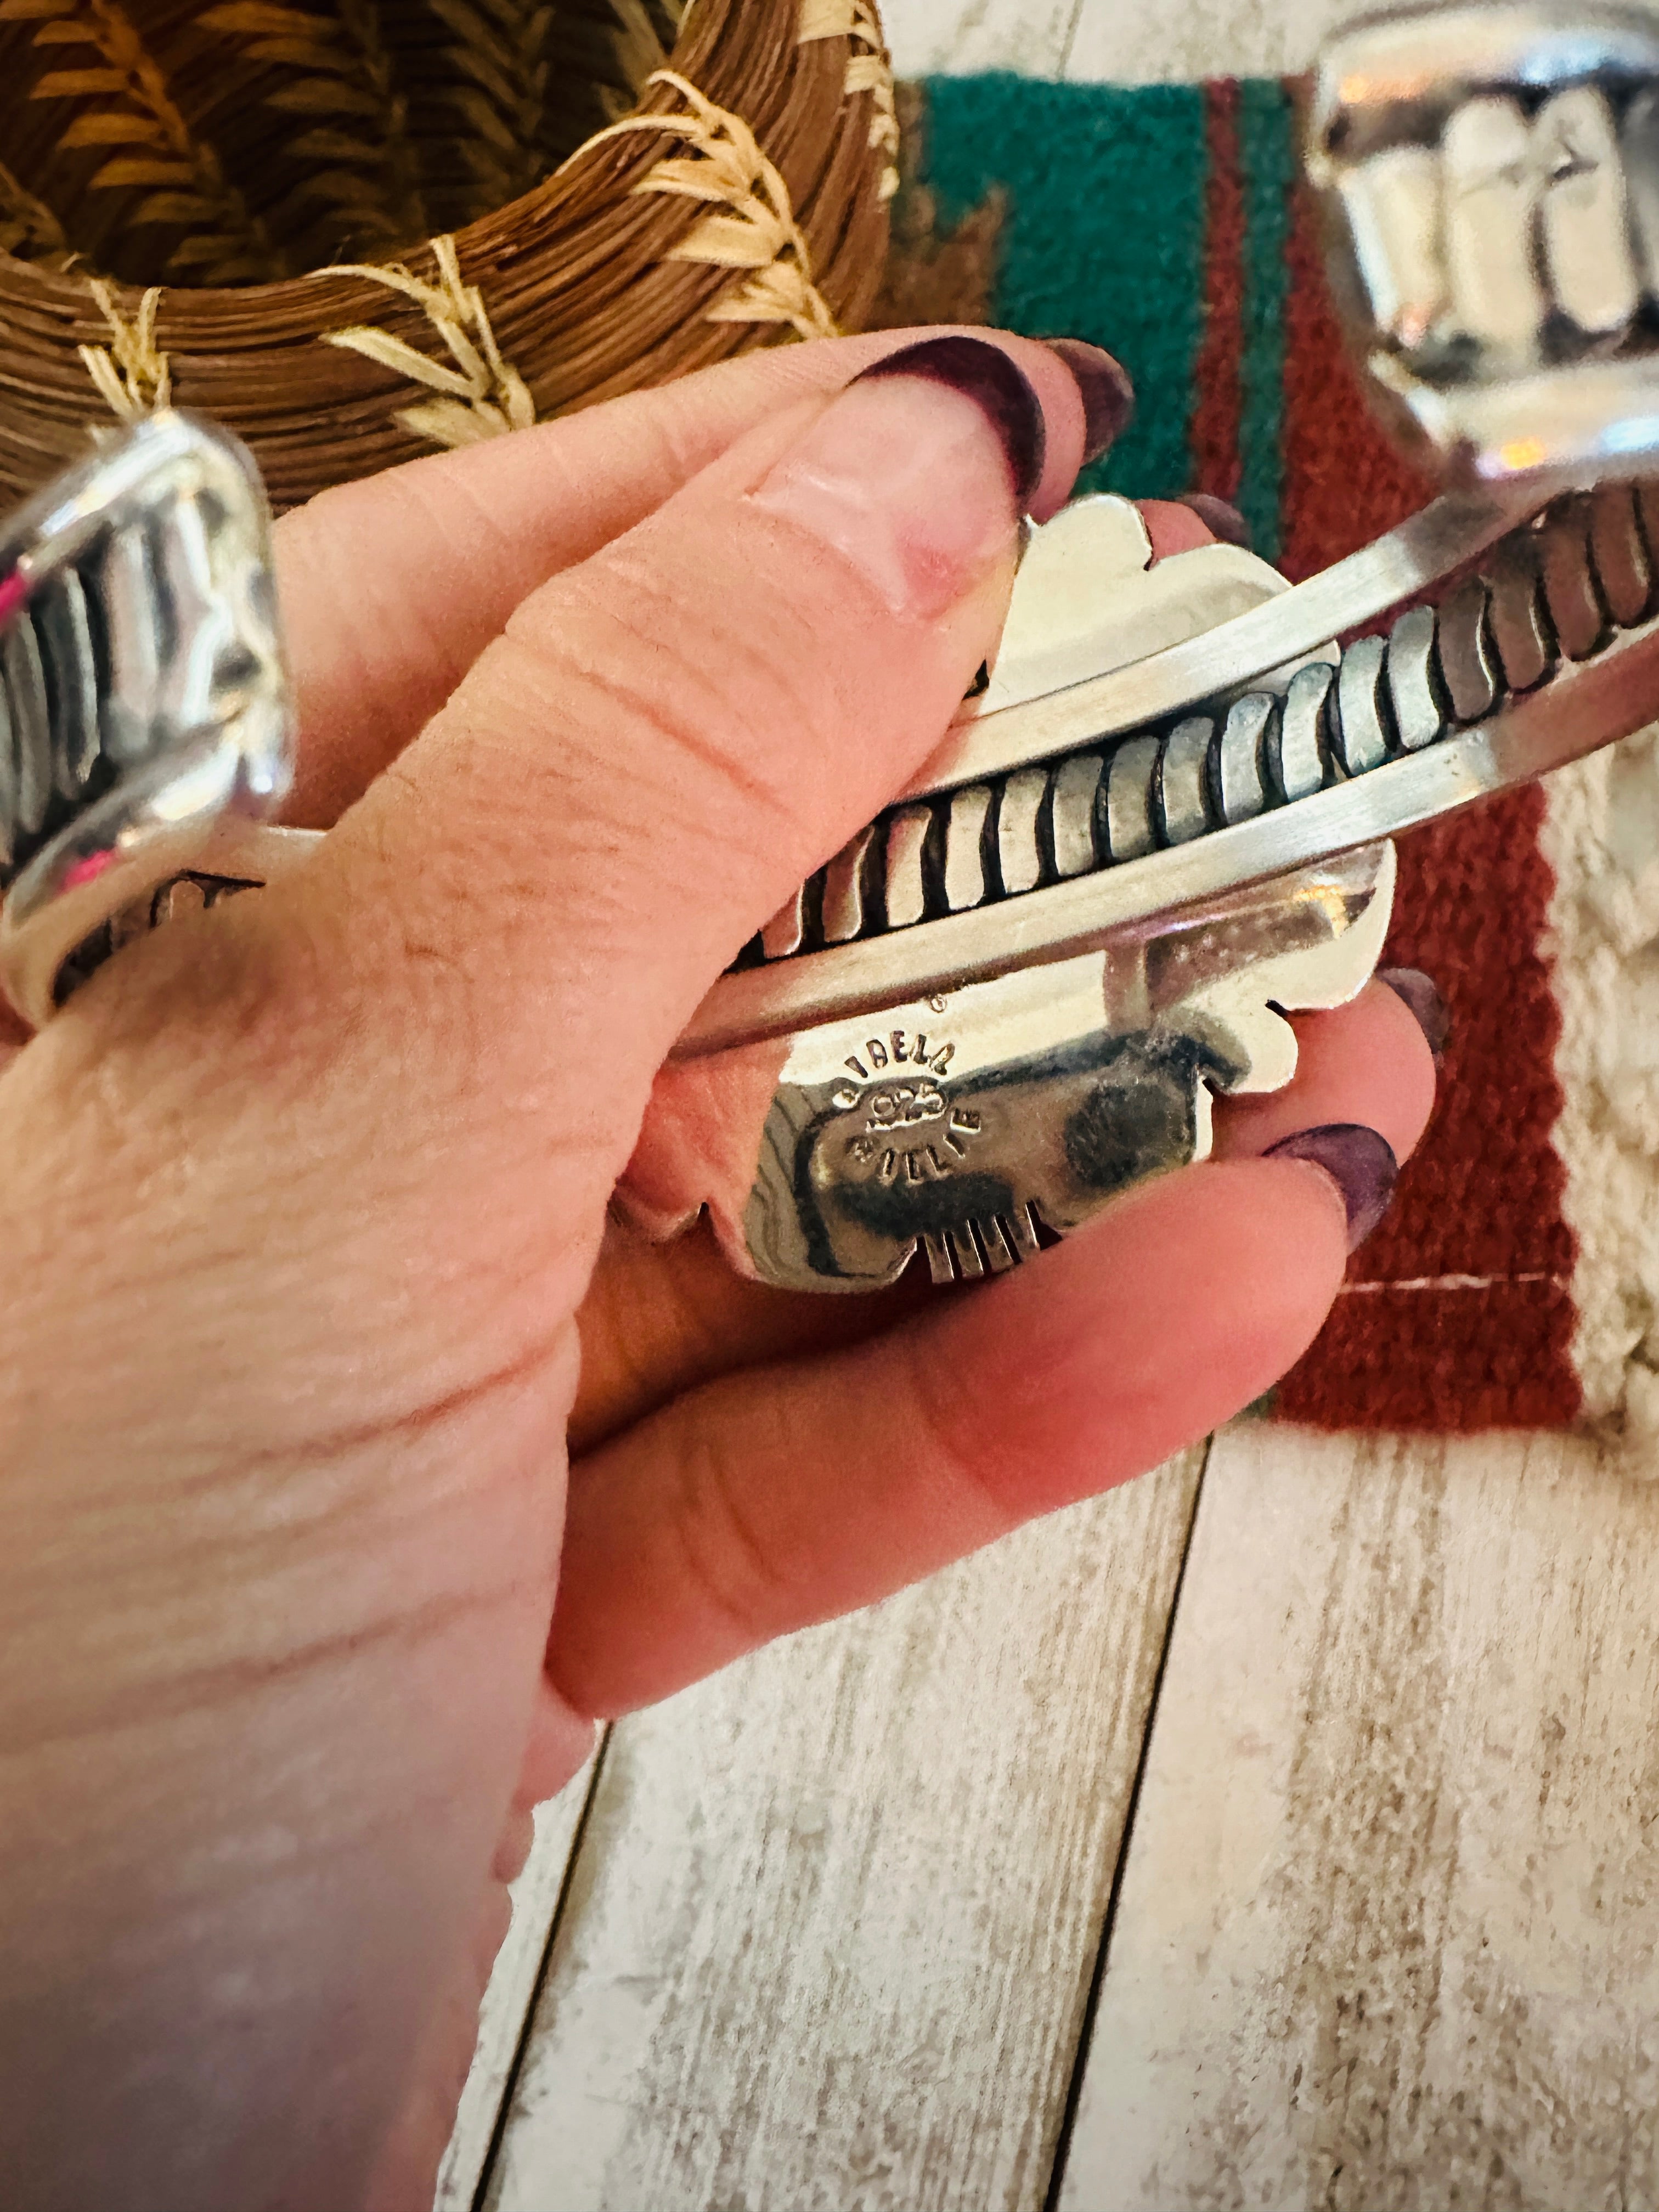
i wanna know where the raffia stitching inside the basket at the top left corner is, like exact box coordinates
[0,0,287,283]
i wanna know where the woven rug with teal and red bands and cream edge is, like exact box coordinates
[883,75,1659,1440]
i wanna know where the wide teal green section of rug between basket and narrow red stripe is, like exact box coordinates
[924,77,1212,502]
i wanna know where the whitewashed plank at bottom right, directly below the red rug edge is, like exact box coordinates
[1062,1425,1659,2212]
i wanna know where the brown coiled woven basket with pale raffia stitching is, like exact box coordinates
[0,0,896,509]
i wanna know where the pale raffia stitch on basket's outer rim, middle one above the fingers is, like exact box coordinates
[314,236,535,447]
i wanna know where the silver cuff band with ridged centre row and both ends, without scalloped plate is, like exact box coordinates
[0,4,1659,1051]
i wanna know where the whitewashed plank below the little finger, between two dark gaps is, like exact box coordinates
[487,1451,1201,2212]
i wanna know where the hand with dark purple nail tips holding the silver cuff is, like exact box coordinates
[0,334,1434,2212]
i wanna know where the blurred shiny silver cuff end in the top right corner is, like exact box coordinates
[1307,0,1659,482]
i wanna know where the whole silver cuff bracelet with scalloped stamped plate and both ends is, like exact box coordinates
[0,4,1659,1290]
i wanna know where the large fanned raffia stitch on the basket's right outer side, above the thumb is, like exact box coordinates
[584,69,838,338]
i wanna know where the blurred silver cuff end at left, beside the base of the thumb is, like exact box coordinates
[0,411,292,1026]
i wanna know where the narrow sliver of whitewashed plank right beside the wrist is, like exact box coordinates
[433,1758,595,2212]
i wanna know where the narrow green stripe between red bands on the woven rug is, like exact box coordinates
[1239,77,1296,560]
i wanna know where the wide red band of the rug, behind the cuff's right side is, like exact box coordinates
[1278,197,1579,1429]
